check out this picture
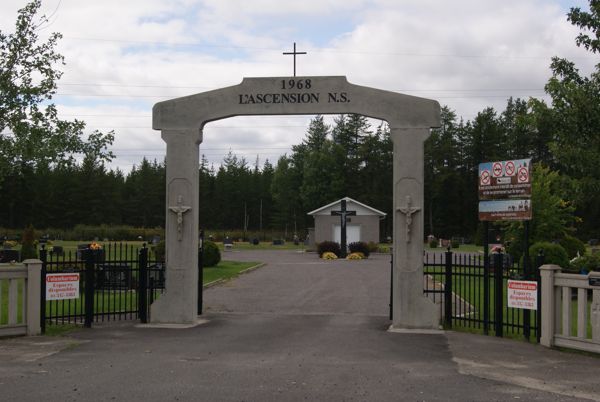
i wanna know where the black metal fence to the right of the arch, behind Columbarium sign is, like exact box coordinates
[423,251,543,341]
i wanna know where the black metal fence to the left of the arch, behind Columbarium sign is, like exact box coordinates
[40,243,165,330]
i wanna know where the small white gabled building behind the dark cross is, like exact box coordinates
[308,197,386,244]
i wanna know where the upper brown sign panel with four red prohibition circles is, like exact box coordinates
[479,159,531,200]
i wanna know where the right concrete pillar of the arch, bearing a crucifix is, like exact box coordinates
[391,127,440,329]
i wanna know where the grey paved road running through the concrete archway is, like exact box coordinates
[0,251,600,401]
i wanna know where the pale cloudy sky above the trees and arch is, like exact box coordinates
[0,0,600,172]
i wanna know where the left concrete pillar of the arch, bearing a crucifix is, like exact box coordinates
[150,130,202,323]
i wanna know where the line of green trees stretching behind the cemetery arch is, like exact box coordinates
[0,1,600,240]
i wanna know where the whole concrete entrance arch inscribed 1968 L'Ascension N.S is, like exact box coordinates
[151,76,440,330]
